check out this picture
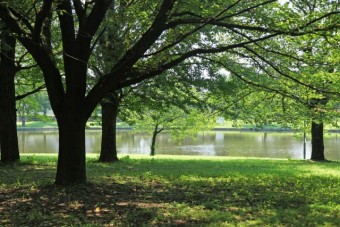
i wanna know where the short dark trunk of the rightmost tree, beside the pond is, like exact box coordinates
[311,121,325,161]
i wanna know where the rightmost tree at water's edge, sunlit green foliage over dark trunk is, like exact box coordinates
[207,30,340,161]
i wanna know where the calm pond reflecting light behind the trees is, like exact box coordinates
[18,130,340,161]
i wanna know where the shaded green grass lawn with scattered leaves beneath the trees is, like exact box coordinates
[0,155,340,226]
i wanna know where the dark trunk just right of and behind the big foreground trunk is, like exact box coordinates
[99,101,119,162]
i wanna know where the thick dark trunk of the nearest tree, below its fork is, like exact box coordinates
[55,112,86,185]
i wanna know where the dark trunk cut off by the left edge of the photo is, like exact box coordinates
[0,32,20,162]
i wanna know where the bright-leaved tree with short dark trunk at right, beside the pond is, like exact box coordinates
[199,1,340,161]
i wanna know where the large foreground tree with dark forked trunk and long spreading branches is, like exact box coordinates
[0,0,338,185]
